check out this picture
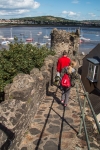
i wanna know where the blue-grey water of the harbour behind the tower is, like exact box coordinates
[0,27,100,53]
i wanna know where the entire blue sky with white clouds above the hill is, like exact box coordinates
[0,0,100,20]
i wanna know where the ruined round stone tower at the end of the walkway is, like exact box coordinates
[51,28,80,57]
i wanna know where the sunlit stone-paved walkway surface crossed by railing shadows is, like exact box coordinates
[20,86,87,150]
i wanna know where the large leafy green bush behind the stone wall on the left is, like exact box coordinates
[0,41,55,92]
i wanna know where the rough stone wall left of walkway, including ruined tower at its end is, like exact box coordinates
[0,29,78,150]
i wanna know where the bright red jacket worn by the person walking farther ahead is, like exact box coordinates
[57,56,71,72]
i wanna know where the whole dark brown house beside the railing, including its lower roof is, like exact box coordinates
[81,44,100,117]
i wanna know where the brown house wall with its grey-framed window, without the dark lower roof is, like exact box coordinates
[81,44,100,93]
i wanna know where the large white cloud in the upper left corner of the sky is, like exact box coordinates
[0,0,40,17]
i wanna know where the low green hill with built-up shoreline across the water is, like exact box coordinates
[0,16,100,27]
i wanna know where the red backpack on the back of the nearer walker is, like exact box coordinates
[61,73,71,88]
